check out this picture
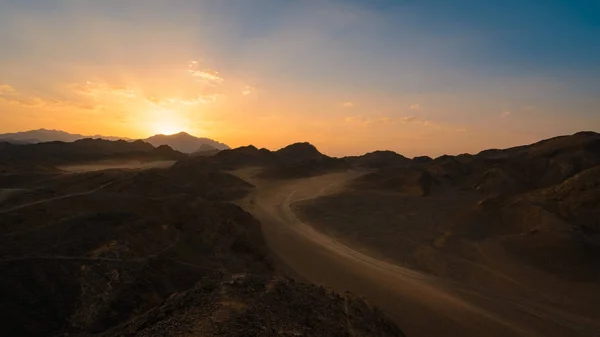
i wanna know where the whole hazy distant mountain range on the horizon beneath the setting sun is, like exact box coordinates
[0,129,229,153]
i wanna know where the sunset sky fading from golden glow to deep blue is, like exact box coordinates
[0,0,600,156]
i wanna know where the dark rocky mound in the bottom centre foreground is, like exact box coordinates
[102,275,404,337]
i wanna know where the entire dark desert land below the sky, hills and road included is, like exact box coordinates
[0,132,600,337]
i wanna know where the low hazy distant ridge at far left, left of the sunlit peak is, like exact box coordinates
[0,129,131,144]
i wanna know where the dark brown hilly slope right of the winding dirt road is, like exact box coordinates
[295,132,600,317]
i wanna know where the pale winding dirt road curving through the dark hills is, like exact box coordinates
[235,170,600,337]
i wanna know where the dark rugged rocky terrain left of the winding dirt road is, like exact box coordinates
[0,143,402,336]
